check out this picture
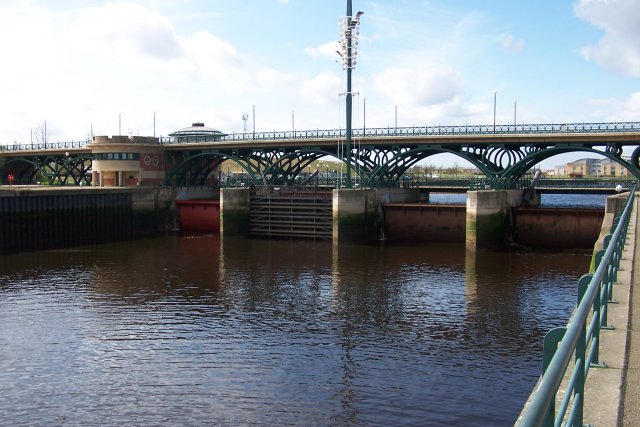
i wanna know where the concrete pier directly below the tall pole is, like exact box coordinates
[333,189,382,243]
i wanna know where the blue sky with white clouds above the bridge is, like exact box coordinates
[0,0,640,166]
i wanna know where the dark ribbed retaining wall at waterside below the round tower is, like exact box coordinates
[0,187,174,253]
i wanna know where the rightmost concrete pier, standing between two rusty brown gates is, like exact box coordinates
[466,190,522,251]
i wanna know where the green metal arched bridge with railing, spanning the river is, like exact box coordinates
[0,122,640,189]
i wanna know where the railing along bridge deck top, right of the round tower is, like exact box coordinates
[160,122,640,144]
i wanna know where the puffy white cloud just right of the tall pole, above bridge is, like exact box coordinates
[374,63,463,107]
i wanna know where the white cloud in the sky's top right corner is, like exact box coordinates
[574,0,640,78]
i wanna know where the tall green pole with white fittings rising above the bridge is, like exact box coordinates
[338,0,364,188]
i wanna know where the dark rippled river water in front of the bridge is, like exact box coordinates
[0,236,589,426]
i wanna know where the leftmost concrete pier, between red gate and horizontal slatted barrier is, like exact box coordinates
[220,188,251,237]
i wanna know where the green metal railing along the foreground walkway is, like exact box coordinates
[516,186,636,427]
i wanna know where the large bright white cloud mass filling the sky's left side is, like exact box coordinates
[0,1,260,141]
